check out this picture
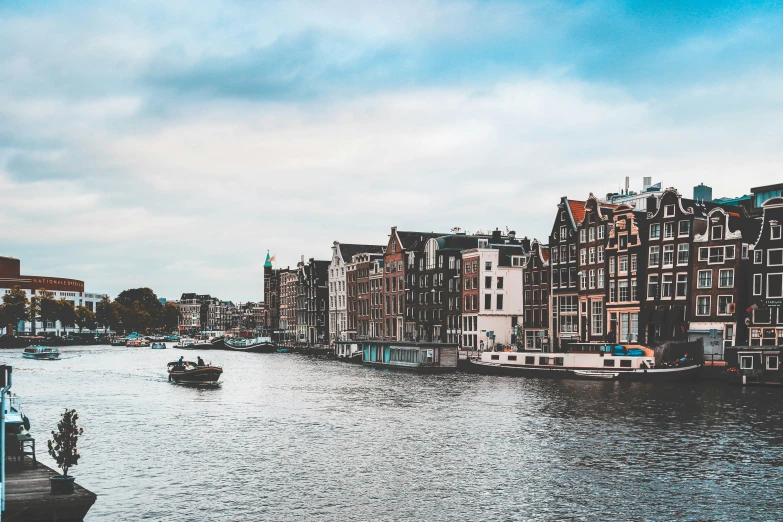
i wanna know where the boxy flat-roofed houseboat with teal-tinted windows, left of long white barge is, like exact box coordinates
[360,341,458,373]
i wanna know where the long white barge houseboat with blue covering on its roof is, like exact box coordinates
[465,343,703,381]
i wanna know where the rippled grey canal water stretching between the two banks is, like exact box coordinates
[7,347,783,521]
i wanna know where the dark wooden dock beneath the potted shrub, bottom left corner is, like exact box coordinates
[3,459,97,522]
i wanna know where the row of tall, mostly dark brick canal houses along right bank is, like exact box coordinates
[265,184,783,359]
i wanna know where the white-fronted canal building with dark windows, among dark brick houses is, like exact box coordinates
[462,245,525,349]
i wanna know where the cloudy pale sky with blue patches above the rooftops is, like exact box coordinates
[0,0,783,301]
